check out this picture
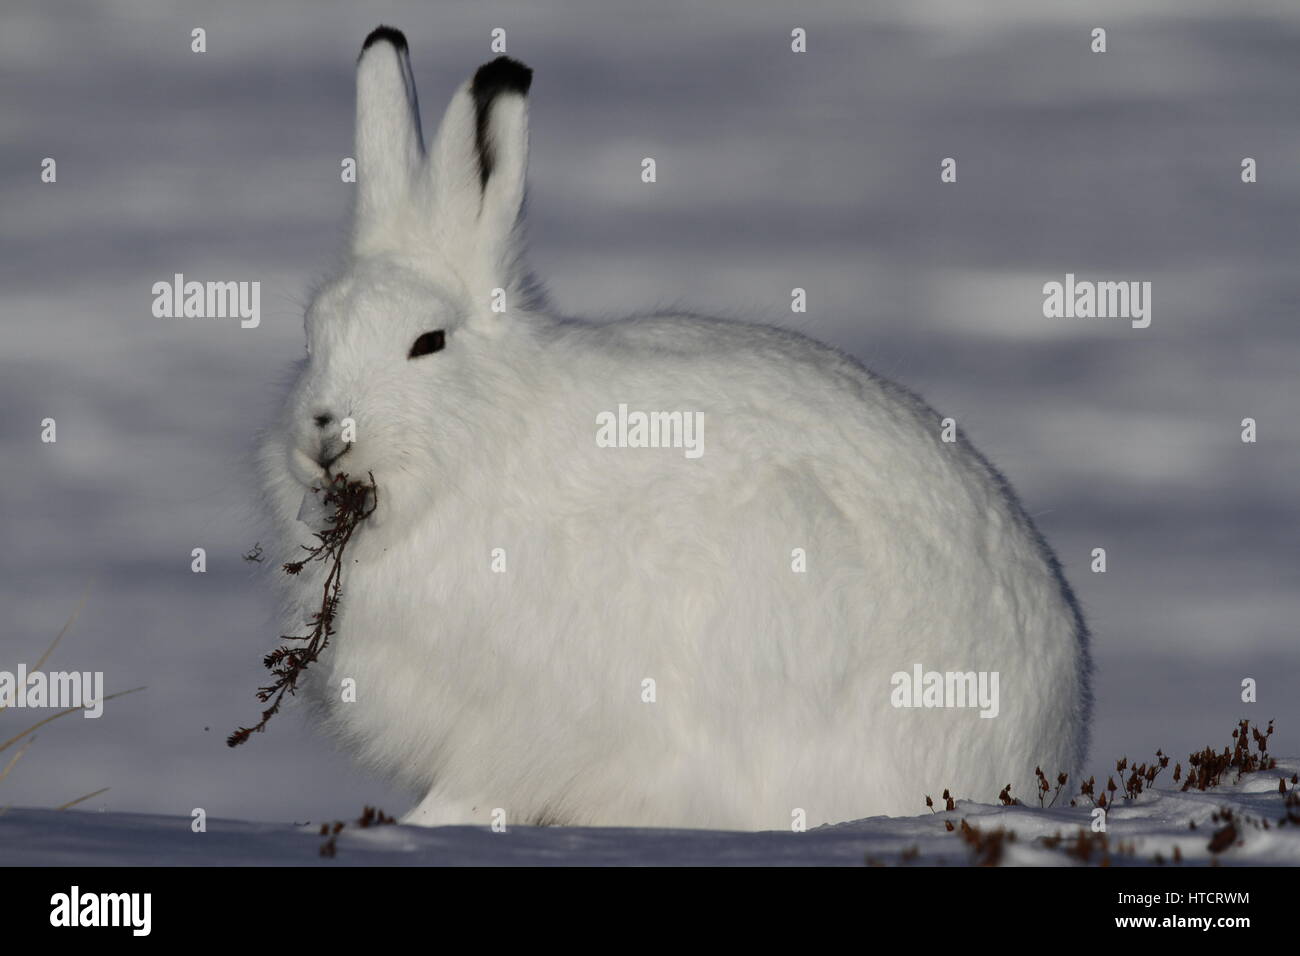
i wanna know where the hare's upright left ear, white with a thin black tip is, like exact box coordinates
[354,26,424,248]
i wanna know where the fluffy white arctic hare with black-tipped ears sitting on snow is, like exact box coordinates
[259,27,1089,830]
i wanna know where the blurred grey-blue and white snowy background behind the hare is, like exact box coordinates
[0,0,1300,821]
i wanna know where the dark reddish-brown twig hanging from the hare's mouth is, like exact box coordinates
[226,472,380,747]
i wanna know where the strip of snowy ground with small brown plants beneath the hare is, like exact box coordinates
[0,760,1300,866]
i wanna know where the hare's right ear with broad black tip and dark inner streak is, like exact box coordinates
[430,56,533,286]
